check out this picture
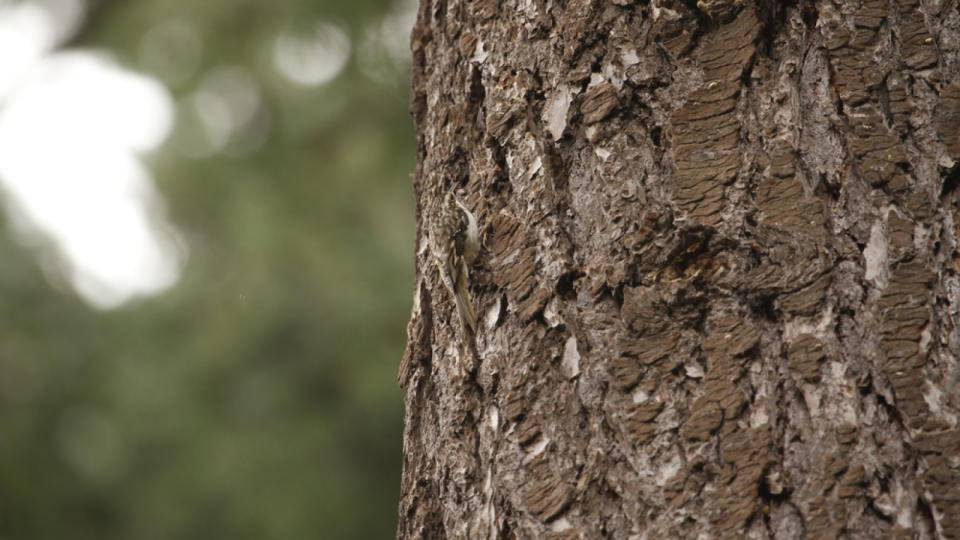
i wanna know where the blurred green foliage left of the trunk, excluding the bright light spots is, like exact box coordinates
[0,0,414,540]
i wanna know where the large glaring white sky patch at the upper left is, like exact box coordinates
[0,4,183,308]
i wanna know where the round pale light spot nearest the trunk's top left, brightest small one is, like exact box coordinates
[273,22,350,86]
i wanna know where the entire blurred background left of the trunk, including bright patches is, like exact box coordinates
[0,0,416,540]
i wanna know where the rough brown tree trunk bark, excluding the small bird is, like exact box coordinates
[398,0,960,539]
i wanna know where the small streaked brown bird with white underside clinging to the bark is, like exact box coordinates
[428,192,480,333]
